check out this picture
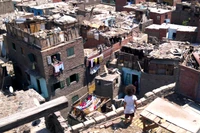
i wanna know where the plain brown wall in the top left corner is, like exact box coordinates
[0,0,14,14]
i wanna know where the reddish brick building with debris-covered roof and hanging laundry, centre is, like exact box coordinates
[81,12,138,83]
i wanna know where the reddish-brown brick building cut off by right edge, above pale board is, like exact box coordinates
[175,45,200,102]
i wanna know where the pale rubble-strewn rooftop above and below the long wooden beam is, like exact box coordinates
[0,89,49,133]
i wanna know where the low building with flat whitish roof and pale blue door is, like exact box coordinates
[145,23,197,42]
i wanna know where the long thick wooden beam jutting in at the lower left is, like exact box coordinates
[0,96,68,132]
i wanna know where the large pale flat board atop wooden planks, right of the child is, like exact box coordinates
[145,98,200,132]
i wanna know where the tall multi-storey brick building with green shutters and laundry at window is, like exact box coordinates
[5,16,85,101]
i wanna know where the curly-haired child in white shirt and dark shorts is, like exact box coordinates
[124,84,137,123]
